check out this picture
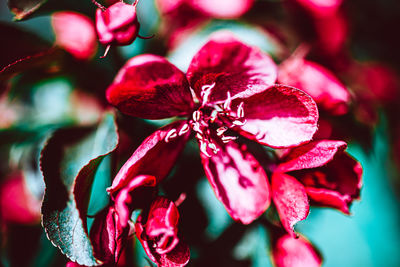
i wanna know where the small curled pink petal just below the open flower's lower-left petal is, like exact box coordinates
[115,175,156,227]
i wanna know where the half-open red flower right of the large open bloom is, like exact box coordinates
[272,140,362,236]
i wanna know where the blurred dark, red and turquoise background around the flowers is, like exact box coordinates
[0,0,400,267]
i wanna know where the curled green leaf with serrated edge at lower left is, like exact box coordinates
[40,114,118,266]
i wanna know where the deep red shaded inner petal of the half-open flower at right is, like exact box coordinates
[296,153,362,214]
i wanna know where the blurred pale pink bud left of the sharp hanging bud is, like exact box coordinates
[51,11,97,60]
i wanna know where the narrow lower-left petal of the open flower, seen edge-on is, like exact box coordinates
[107,121,190,197]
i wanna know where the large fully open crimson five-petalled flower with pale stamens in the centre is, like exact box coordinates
[106,32,318,227]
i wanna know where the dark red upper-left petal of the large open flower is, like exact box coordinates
[106,55,193,119]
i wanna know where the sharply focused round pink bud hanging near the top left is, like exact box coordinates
[96,2,140,45]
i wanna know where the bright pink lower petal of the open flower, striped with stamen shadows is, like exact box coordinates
[200,142,270,224]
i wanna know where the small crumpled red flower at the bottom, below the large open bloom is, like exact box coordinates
[135,197,190,267]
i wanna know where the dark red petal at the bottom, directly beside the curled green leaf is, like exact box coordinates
[90,207,129,263]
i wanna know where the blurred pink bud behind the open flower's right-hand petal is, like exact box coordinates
[278,58,350,115]
